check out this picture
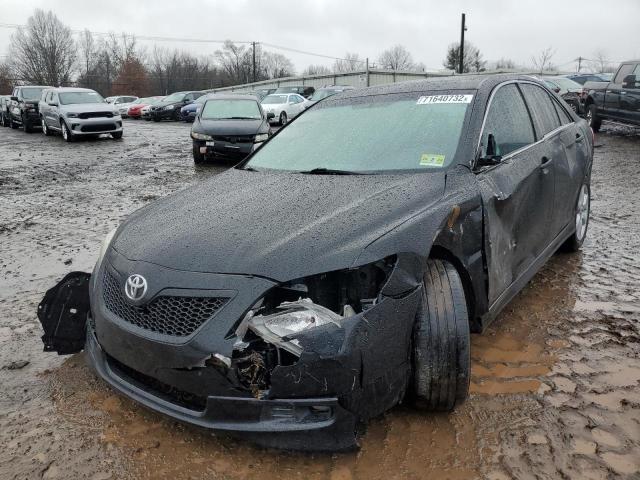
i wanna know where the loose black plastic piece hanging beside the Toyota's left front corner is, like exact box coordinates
[38,272,91,355]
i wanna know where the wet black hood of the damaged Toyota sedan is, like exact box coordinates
[112,169,445,281]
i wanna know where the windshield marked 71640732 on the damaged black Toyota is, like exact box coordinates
[245,92,473,173]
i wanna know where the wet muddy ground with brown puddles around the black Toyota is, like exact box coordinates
[0,121,640,480]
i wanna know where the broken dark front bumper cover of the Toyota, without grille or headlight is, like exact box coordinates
[37,249,421,451]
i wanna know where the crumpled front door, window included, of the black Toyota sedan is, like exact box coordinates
[476,83,554,305]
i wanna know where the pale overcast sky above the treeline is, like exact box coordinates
[0,0,640,71]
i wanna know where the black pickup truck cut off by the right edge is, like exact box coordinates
[584,60,640,132]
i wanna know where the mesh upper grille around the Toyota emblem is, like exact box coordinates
[103,271,229,337]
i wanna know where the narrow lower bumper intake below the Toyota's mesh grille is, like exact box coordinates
[107,355,207,412]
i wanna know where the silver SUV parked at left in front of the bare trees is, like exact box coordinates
[39,87,122,142]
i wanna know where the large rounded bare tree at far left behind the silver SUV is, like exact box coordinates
[10,9,76,86]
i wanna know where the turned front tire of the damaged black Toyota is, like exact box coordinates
[413,259,471,412]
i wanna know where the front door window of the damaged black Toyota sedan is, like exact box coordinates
[482,83,535,156]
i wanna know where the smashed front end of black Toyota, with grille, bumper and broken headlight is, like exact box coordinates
[38,249,421,451]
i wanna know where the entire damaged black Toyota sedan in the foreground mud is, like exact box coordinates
[38,76,593,450]
